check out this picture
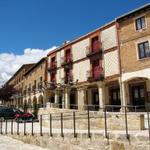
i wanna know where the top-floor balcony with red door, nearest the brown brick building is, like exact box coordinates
[86,41,102,57]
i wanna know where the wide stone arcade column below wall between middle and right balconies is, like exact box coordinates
[77,88,85,111]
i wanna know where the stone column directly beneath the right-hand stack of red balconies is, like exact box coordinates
[98,83,105,108]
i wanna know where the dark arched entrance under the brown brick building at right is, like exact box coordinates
[123,77,149,111]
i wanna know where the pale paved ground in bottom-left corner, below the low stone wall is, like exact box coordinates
[0,135,48,150]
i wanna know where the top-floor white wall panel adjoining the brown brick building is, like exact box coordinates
[101,25,117,50]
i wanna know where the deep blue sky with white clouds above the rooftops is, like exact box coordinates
[0,0,149,85]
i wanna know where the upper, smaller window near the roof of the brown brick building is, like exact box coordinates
[135,16,146,30]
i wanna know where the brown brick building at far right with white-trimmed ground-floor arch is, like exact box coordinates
[117,4,150,108]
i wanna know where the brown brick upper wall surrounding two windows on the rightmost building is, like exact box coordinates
[119,11,150,73]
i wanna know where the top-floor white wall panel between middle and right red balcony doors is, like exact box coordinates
[72,38,90,61]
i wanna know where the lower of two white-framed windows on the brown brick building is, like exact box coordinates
[138,41,150,59]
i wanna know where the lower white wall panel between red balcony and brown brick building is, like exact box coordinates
[104,50,119,77]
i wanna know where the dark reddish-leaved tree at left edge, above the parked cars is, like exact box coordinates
[0,84,18,103]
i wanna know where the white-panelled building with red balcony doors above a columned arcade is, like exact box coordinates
[47,21,121,110]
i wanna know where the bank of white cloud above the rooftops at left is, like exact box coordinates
[0,46,56,85]
